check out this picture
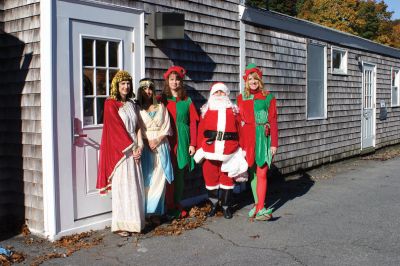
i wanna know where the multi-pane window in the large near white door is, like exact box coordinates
[82,37,121,126]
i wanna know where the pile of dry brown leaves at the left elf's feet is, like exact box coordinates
[153,204,211,236]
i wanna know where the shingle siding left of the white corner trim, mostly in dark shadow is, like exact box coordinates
[0,0,43,235]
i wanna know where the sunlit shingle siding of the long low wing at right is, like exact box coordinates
[242,20,400,174]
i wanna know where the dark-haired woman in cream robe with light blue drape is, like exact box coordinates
[137,78,174,218]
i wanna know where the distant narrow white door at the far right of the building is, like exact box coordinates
[361,63,376,149]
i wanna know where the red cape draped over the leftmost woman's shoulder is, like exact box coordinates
[96,99,133,194]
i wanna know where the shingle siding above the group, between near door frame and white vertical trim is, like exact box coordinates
[96,0,240,196]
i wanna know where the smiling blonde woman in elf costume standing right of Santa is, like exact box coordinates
[237,64,278,221]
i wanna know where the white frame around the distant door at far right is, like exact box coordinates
[361,61,377,150]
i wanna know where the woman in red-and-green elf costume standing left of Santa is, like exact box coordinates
[162,66,199,218]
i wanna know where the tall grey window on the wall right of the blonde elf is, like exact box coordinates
[307,43,327,119]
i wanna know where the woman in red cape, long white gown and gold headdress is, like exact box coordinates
[96,70,144,237]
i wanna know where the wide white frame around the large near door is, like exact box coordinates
[48,0,145,239]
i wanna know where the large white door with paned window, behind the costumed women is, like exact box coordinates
[71,20,135,220]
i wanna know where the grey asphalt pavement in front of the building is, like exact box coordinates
[0,151,400,266]
